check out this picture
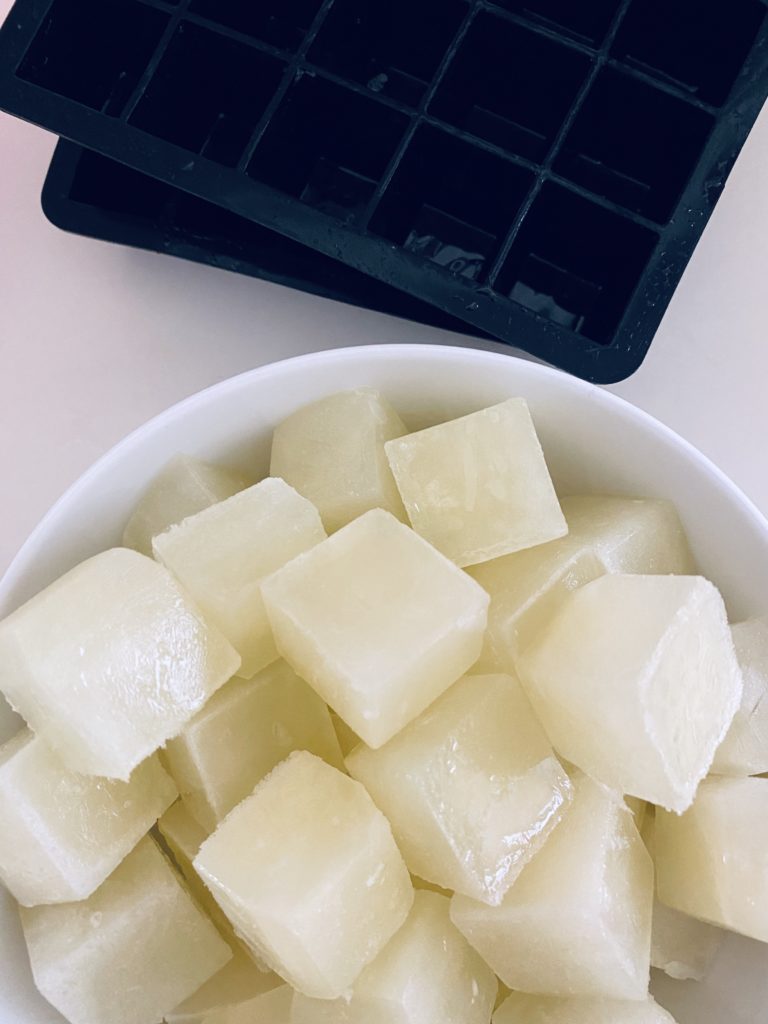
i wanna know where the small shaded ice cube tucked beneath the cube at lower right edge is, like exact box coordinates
[650,900,725,981]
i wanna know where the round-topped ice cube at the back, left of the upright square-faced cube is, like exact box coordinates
[269,388,406,532]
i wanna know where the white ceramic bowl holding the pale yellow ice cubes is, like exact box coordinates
[0,345,768,1024]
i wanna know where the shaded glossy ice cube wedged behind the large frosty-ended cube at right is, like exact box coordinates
[470,496,693,671]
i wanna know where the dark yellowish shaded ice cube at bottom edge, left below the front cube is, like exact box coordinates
[165,946,283,1024]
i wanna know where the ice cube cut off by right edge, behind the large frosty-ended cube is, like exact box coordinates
[712,617,768,775]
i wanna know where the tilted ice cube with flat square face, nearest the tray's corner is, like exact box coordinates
[385,398,567,565]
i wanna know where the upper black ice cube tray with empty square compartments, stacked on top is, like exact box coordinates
[0,0,768,382]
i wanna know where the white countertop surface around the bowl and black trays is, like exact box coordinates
[0,65,768,572]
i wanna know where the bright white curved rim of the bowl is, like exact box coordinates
[0,342,768,606]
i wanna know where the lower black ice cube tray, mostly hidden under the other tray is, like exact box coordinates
[43,139,487,335]
